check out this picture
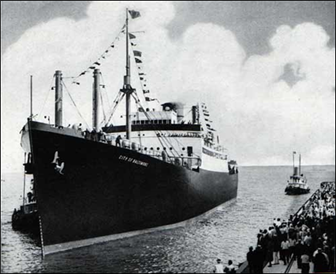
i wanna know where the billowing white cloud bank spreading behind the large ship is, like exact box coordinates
[1,2,335,173]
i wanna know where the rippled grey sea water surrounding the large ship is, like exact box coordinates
[1,166,335,273]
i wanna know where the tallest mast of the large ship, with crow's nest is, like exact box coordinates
[120,9,135,140]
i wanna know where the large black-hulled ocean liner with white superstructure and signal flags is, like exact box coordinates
[13,10,238,255]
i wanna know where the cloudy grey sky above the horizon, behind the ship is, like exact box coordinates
[1,1,335,172]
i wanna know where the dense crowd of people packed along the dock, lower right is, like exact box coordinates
[247,182,335,273]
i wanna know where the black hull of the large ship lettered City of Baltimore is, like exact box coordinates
[30,123,238,254]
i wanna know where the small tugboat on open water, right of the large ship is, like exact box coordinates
[285,151,310,195]
